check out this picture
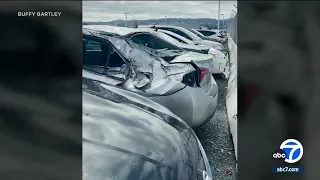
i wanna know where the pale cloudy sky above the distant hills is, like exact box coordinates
[83,1,237,21]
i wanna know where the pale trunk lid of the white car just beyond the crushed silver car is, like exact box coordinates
[171,52,214,71]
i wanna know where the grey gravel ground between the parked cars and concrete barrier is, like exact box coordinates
[195,77,236,180]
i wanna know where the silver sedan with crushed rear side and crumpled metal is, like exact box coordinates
[82,28,218,127]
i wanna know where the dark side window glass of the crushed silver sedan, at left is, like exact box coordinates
[83,39,129,79]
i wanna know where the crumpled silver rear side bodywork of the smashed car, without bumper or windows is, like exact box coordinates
[83,28,195,96]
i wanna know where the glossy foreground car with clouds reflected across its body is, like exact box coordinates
[82,78,212,180]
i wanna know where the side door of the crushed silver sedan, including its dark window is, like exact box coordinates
[83,36,130,85]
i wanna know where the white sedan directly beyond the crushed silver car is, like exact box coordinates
[86,25,219,74]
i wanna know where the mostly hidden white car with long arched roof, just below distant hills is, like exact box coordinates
[140,25,225,48]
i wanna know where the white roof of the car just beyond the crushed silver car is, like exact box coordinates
[83,25,154,36]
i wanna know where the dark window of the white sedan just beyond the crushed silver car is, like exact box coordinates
[130,34,181,50]
